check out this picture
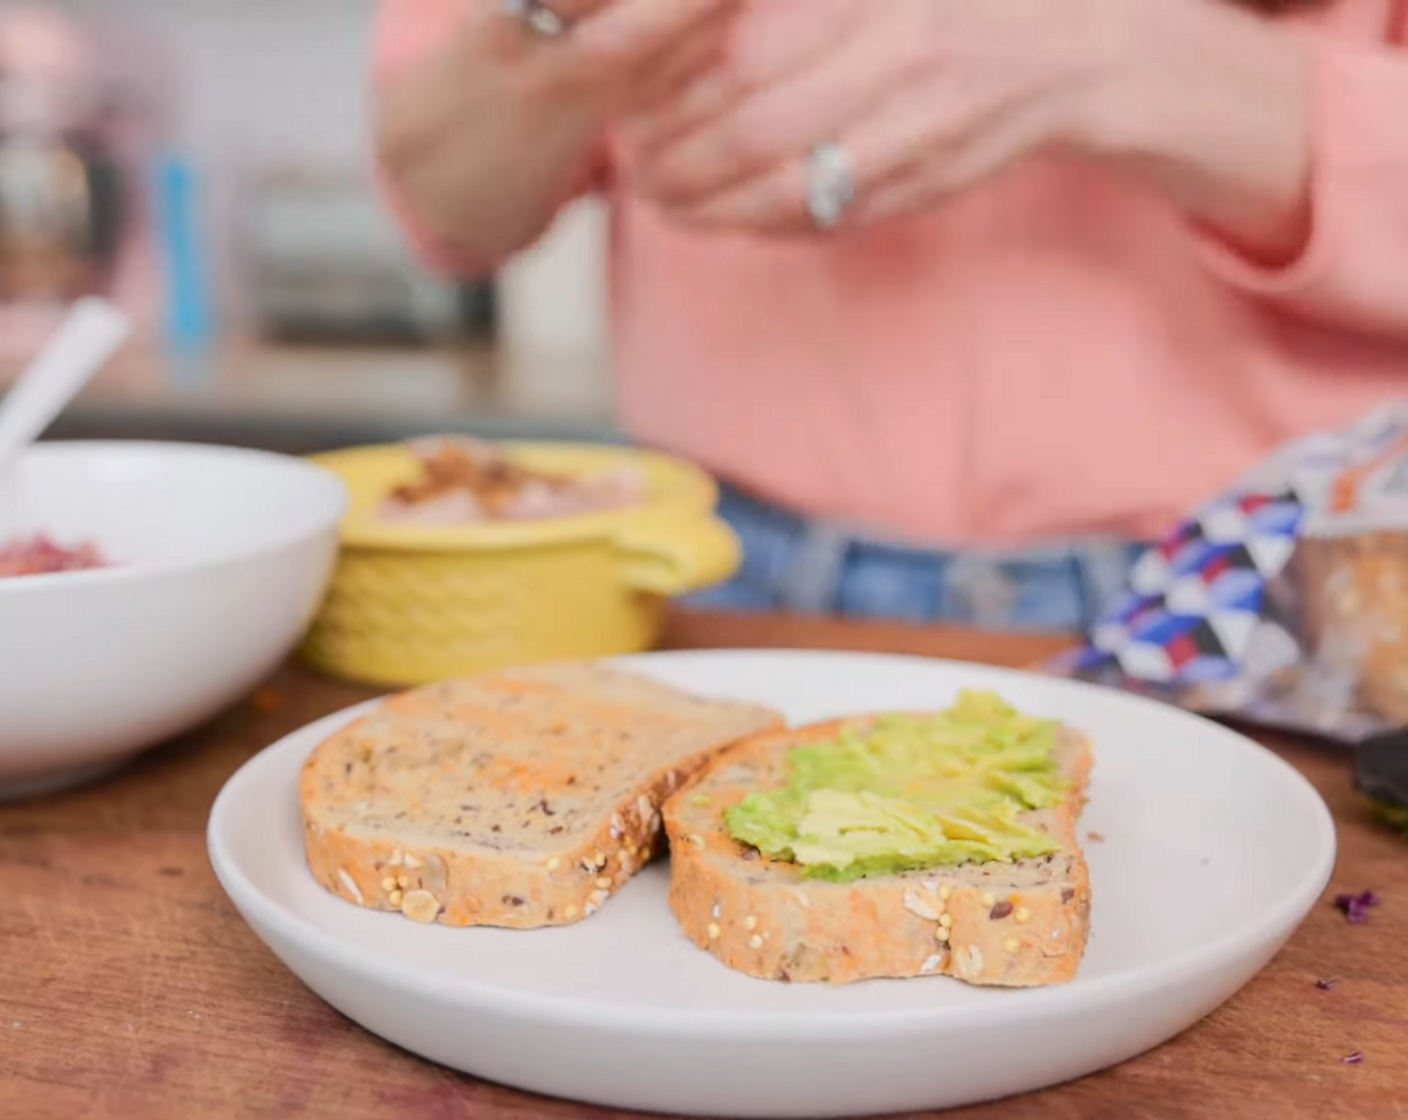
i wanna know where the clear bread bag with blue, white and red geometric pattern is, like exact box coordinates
[1049,402,1408,742]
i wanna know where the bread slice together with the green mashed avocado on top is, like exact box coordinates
[665,692,1093,988]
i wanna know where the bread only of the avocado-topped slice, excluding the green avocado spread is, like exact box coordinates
[665,717,1091,988]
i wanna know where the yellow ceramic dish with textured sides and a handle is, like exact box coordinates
[303,444,739,687]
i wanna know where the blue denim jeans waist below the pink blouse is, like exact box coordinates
[684,487,1143,631]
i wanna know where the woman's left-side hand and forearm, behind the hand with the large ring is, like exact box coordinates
[377,0,738,269]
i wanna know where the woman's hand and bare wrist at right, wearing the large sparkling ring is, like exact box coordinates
[629,0,1308,256]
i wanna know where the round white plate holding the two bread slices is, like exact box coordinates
[210,652,1335,1117]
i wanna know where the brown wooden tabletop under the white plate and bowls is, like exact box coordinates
[0,617,1408,1120]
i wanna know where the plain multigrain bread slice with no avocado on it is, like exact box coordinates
[300,664,783,928]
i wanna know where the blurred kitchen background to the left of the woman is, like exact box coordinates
[0,0,617,452]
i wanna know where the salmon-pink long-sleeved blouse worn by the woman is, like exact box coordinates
[377,0,1408,547]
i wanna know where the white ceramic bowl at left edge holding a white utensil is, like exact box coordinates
[0,442,346,799]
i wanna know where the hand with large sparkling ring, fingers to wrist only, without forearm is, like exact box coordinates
[631,0,1115,232]
